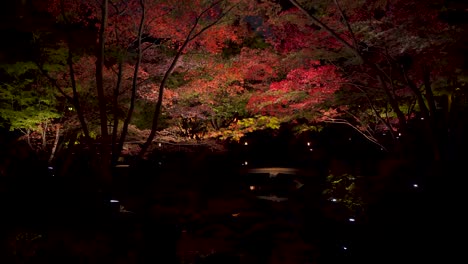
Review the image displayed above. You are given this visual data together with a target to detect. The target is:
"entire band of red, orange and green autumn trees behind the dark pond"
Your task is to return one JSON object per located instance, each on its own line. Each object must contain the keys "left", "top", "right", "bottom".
{"left": 0, "top": 0, "right": 467, "bottom": 175}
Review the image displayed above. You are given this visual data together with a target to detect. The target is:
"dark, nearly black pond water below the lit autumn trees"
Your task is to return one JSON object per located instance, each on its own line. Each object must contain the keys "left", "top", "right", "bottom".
{"left": 0, "top": 150, "right": 455, "bottom": 264}
